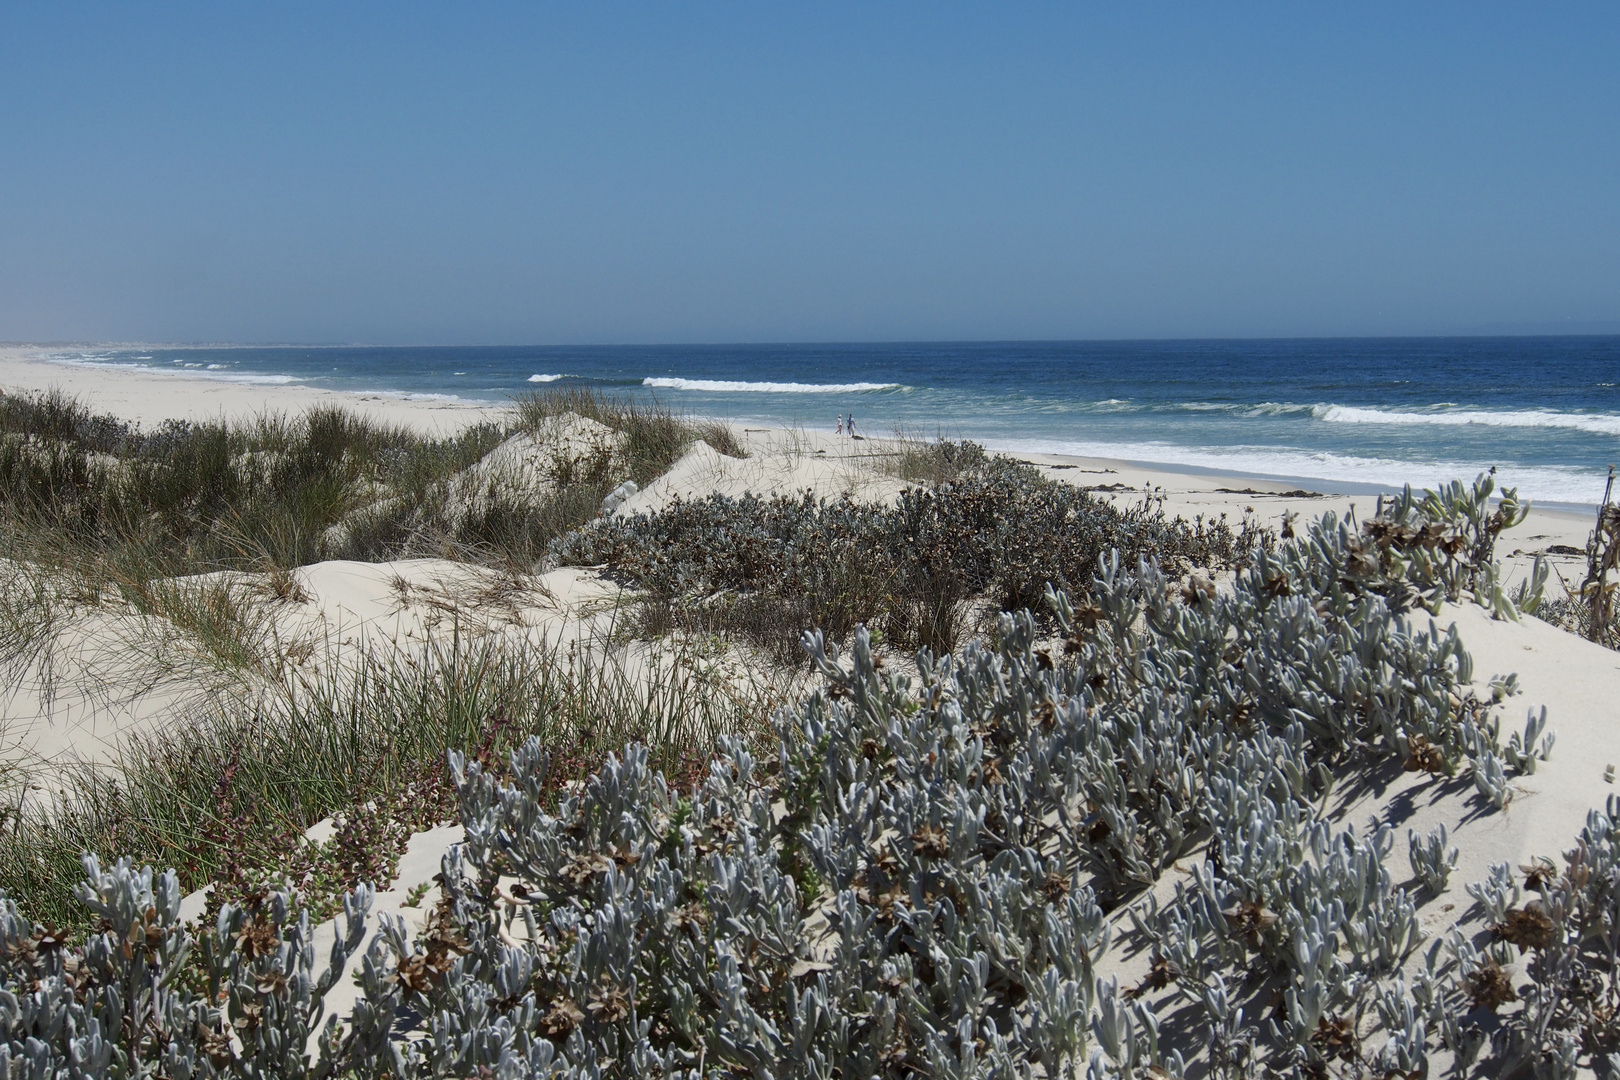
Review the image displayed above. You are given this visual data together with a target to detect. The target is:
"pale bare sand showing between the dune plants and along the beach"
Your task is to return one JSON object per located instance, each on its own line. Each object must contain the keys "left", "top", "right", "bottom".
{"left": 0, "top": 341, "right": 1620, "bottom": 1068}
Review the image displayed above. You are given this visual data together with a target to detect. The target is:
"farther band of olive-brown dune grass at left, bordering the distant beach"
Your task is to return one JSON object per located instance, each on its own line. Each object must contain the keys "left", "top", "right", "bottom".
{"left": 0, "top": 389, "right": 740, "bottom": 583}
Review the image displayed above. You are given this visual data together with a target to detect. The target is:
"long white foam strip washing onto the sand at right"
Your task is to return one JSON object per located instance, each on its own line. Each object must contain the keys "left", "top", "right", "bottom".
{"left": 985, "top": 439, "right": 1604, "bottom": 505}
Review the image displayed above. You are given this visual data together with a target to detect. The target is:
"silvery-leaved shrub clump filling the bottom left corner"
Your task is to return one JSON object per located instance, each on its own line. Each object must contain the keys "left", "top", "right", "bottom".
{"left": 0, "top": 855, "right": 392, "bottom": 1080}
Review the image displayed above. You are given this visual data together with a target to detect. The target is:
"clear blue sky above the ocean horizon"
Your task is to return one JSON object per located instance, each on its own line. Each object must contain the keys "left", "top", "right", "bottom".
{"left": 0, "top": 0, "right": 1620, "bottom": 345}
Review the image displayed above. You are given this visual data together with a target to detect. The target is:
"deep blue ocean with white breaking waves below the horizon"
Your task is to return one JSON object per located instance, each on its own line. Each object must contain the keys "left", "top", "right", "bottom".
{"left": 38, "top": 337, "right": 1620, "bottom": 507}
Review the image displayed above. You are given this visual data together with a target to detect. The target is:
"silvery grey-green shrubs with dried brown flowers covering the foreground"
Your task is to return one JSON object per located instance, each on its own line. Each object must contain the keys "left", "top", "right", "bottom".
{"left": 0, "top": 476, "right": 1620, "bottom": 1080}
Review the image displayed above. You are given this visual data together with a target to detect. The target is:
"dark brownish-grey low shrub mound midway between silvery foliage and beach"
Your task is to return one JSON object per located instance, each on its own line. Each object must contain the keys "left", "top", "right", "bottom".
{"left": 551, "top": 444, "right": 1270, "bottom": 664}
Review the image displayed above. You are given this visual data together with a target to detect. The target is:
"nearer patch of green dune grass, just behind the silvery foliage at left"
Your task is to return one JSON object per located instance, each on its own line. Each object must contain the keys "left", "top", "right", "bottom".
{"left": 0, "top": 636, "right": 784, "bottom": 923}
